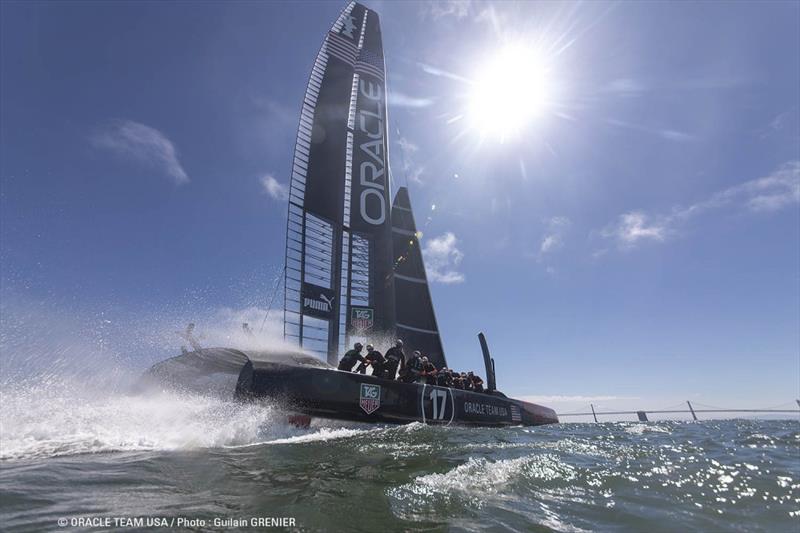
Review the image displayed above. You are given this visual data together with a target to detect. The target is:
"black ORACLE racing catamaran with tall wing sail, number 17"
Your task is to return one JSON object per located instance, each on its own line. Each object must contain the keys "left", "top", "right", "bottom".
{"left": 147, "top": 2, "right": 558, "bottom": 426}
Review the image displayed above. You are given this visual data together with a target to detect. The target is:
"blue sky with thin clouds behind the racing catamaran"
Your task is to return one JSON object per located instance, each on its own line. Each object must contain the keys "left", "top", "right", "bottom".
{"left": 0, "top": 1, "right": 800, "bottom": 418}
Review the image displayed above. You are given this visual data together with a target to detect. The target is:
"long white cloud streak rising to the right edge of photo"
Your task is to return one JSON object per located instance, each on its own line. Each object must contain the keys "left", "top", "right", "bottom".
{"left": 600, "top": 161, "right": 800, "bottom": 248}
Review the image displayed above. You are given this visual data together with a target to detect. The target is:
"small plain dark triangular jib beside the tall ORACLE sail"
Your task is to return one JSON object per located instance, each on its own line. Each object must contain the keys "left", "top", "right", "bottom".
{"left": 392, "top": 187, "right": 447, "bottom": 368}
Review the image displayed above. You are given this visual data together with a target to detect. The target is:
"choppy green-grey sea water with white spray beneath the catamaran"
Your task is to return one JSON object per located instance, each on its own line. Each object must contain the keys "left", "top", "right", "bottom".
{"left": 0, "top": 383, "right": 800, "bottom": 532}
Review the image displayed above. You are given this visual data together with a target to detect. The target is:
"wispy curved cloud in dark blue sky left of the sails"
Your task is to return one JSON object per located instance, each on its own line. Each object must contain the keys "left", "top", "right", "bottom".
{"left": 90, "top": 120, "right": 189, "bottom": 185}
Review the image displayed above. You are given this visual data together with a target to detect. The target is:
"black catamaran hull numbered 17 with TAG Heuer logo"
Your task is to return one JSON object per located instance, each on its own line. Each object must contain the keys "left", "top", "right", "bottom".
{"left": 142, "top": 349, "right": 558, "bottom": 427}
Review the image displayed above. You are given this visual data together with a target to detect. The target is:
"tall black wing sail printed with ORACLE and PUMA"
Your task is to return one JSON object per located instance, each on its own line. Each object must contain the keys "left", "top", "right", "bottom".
{"left": 284, "top": 2, "right": 395, "bottom": 363}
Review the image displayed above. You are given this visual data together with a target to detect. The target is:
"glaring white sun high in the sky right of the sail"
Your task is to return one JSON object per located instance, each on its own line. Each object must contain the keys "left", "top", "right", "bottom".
{"left": 468, "top": 45, "right": 551, "bottom": 142}
